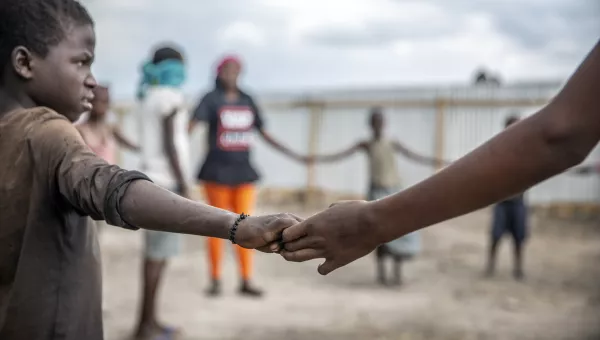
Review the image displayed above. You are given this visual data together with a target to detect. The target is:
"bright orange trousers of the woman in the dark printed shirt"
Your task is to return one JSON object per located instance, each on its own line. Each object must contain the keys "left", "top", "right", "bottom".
{"left": 203, "top": 183, "right": 256, "bottom": 280}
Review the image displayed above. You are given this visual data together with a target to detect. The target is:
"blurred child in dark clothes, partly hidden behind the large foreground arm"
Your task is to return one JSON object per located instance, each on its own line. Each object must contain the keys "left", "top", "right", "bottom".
{"left": 485, "top": 116, "right": 528, "bottom": 280}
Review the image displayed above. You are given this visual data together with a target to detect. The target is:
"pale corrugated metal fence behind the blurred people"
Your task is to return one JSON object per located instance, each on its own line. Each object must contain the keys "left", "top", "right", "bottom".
{"left": 113, "top": 82, "right": 600, "bottom": 204}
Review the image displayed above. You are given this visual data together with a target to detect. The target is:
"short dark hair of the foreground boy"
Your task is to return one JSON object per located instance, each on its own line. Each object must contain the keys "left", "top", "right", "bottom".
{"left": 0, "top": 0, "right": 94, "bottom": 75}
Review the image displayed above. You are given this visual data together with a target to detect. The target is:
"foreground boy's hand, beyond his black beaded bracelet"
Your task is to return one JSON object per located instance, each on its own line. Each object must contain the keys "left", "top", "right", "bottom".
{"left": 235, "top": 213, "right": 303, "bottom": 253}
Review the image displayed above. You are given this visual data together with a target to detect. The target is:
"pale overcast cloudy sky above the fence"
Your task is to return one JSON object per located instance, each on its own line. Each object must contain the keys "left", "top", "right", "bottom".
{"left": 83, "top": 0, "right": 600, "bottom": 98}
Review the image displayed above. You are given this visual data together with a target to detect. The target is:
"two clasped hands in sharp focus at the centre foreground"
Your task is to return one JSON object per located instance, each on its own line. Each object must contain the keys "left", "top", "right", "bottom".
{"left": 236, "top": 201, "right": 386, "bottom": 275}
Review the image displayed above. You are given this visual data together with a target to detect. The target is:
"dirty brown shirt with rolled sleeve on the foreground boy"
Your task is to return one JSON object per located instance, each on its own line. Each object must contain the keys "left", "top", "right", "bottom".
{"left": 0, "top": 108, "right": 146, "bottom": 340}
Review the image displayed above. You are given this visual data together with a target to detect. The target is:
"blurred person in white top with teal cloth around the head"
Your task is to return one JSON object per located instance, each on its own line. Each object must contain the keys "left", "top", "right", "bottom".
{"left": 135, "top": 47, "right": 190, "bottom": 339}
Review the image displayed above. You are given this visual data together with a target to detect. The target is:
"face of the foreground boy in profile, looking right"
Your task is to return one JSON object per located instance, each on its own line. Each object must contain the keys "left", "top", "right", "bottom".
{"left": 28, "top": 25, "right": 97, "bottom": 121}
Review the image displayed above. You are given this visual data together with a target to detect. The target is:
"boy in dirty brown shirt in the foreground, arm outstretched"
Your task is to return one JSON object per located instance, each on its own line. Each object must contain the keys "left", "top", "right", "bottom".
{"left": 0, "top": 0, "right": 299, "bottom": 340}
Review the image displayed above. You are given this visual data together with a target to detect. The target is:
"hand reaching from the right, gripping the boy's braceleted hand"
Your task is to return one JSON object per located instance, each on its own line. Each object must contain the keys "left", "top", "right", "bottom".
{"left": 281, "top": 201, "right": 385, "bottom": 275}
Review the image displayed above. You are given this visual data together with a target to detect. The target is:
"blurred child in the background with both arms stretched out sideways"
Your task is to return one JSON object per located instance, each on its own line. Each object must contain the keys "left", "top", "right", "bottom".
{"left": 309, "top": 108, "right": 443, "bottom": 285}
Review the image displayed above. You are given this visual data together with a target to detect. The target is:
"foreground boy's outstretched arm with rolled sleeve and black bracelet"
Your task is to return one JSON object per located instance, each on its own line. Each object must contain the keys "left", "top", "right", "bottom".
{"left": 29, "top": 112, "right": 300, "bottom": 251}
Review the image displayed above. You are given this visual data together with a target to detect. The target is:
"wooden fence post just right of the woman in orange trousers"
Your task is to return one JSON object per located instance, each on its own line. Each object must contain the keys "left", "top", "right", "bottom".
{"left": 304, "top": 102, "right": 324, "bottom": 208}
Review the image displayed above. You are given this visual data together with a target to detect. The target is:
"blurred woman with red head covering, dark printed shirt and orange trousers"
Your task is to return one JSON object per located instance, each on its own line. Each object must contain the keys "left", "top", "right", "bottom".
{"left": 189, "top": 56, "right": 301, "bottom": 297}
